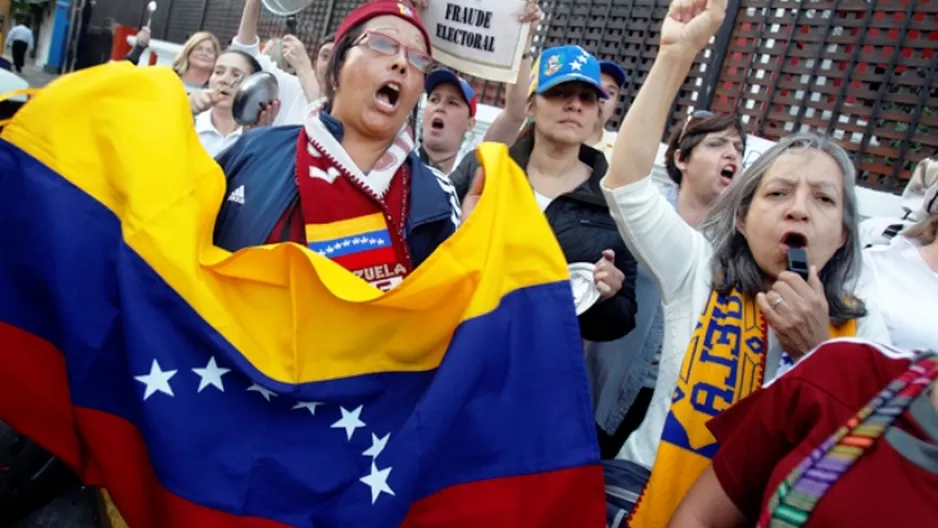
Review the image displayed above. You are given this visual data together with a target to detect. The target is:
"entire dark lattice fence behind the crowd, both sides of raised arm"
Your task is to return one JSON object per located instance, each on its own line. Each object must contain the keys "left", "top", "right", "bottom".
{"left": 84, "top": 0, "right": 938, "bottom": 192}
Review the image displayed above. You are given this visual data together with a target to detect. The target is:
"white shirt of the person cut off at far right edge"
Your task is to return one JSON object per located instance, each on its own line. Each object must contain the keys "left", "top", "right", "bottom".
{"left": 856, "top": 235, "right": 938, "bottom": 350}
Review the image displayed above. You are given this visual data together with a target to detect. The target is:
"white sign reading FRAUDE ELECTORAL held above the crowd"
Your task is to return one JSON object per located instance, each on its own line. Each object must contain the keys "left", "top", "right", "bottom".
{"left": 421, "top": 0, "right": 530, "bottom": 83}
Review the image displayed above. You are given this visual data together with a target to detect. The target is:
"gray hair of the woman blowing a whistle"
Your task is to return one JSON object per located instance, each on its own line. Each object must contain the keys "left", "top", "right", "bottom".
{"left": 700, "top": 132, "right": 866, "bottom": 326}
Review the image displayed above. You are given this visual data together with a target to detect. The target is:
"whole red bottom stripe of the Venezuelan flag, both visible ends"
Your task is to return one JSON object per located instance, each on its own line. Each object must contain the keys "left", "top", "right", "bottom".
{"left": 0, "top": 322, "right": 605, "bottom": 528}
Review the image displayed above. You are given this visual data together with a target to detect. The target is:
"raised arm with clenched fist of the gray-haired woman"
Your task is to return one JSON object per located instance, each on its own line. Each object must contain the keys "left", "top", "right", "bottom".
{"left": 602, "top": 0, "right": 726, "bottom": 303}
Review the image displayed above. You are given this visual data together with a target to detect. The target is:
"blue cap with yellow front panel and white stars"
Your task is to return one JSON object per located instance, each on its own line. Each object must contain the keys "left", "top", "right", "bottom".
{"left": 528, "top": 44, "right": 609, "bottom": 99}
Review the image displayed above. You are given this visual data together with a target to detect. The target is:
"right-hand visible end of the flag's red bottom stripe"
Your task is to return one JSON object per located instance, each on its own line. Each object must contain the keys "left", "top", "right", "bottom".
{"left": 401, "top": 464, "right": 606, "bottom": 528}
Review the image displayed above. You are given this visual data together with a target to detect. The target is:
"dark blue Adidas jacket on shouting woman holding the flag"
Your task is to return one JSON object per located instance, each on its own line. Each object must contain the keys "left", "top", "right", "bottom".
{"left": 215, "top": 113, "right": 459, "bottom": 267}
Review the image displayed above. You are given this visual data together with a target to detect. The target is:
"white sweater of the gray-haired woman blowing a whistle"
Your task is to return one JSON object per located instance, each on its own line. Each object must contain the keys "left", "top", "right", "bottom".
{"left": 603, "top": 177, "right": 889, "bottom": 468}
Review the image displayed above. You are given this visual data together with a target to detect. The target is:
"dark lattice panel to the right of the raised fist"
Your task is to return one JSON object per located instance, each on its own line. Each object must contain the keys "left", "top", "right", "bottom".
{"left": 712, "top": 0, "right": 938, "bottom": 192}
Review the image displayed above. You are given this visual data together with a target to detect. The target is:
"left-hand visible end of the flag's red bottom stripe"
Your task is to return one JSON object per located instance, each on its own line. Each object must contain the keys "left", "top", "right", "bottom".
{"left": 0, "top": 322, "right": 287, "bottom": 528}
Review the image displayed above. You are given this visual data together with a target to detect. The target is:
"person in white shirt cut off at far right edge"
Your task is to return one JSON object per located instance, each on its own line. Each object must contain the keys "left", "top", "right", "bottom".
{"left": 856, "top": 167, "right": 938, "bottom": 350}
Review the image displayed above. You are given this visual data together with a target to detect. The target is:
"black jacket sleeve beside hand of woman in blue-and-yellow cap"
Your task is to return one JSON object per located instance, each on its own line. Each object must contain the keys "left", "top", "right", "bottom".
{"left": 580, "top": 244, "right": 638, "bottom": 341}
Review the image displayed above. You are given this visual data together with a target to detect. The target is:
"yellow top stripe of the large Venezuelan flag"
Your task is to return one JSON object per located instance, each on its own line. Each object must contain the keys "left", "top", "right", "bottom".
{"left": 3, "top": 65, "right": 573, "bottom": 383}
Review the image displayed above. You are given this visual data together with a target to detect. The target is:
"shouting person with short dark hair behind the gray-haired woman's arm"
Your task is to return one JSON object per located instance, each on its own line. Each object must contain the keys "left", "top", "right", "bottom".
{"left": 586, "top": 109, "right": 746, "bottom": 460}
